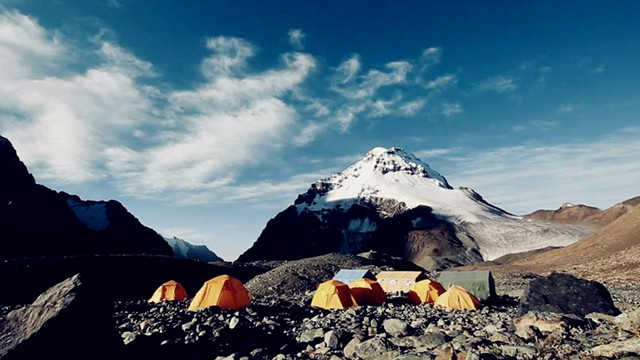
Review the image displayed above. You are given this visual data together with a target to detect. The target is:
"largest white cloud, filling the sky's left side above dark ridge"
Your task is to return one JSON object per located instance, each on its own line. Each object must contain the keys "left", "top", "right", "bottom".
{"left": 0, "top": 12, "right": 322, "bottom": 202}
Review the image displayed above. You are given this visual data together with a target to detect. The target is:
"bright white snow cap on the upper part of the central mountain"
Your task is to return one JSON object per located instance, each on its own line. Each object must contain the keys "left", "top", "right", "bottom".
{"left": 296, "top": 147, "right": 502, "bottom": 222}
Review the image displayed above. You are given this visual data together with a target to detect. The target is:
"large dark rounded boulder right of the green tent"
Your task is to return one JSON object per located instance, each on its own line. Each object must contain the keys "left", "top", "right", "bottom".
{"left": 519, "top": 273, "right": 620, "bottom": 316}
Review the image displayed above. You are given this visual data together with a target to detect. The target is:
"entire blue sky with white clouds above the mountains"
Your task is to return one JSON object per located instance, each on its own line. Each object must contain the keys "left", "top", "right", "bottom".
{"left": 0, "top": 0, "right": 640, "bottom": 260}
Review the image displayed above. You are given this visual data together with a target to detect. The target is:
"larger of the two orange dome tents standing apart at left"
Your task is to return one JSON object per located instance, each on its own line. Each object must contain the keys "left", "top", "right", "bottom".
{"left": 189, "top": 275, "right": 251, "bottom": 310}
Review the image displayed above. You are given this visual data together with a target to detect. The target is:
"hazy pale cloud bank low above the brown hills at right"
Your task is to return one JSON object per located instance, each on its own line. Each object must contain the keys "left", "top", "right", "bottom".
{"left": 448, "top": 128, "right": 640, "bottom": 213}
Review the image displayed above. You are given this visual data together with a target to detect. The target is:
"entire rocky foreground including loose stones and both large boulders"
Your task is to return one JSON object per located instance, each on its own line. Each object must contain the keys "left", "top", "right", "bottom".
{"left": 0, "top": 258, "right": 640, "bottom": 360}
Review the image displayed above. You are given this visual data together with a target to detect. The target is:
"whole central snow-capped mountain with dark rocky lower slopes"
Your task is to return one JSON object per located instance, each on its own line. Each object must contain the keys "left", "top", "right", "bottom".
{"left": 239, "top": 147, "right": 588, "bottom": 269}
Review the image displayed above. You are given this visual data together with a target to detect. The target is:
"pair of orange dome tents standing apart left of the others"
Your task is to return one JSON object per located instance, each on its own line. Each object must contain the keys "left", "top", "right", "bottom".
{"left": 149, "top": 275, "right": 251, "bottom": 311}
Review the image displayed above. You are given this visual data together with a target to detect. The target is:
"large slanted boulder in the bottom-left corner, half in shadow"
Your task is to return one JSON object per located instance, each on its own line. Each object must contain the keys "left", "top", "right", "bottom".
{"left": 0, "top": 274, "right": 122, "bottom": 360}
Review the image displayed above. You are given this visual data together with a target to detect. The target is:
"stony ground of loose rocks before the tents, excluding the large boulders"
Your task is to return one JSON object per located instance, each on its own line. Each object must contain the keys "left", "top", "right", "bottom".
{"left": 114, "top": 274, "right": 640, "bottom": 360}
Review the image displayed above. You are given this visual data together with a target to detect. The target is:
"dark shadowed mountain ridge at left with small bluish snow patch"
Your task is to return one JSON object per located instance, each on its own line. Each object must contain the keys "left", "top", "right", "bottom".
{"left": 0, "top": 136, "right": 173, "bottom": 259}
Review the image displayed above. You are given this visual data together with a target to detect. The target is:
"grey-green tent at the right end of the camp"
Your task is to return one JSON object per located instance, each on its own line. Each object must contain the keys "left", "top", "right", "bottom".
{"left": 438, "top": 270, "right": 496, "bottom": 301}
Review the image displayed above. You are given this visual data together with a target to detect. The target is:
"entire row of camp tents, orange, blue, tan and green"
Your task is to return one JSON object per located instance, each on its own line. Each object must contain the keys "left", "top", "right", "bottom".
{"left": 149, "top": 270, "right": 495, "bottom": 310}
